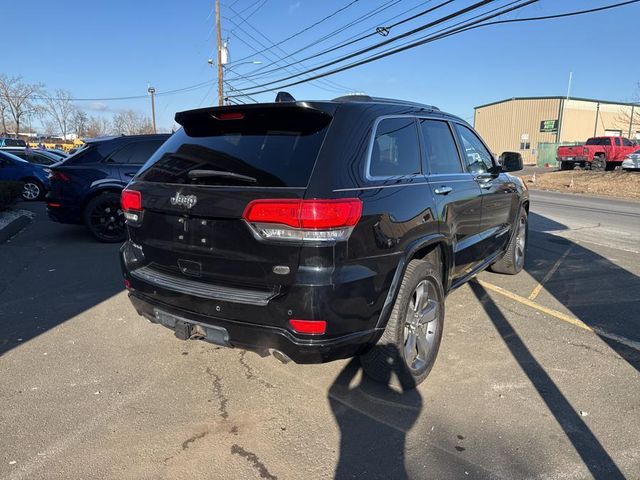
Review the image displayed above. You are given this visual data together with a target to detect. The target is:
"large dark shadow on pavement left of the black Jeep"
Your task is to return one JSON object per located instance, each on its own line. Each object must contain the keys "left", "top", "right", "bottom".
{"left": 0, "top": 204, "right": 123, "bottom": 356}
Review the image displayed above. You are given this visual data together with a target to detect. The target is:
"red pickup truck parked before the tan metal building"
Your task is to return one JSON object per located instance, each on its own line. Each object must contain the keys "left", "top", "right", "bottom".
{"left": 557, "top": 137, "right": 638, "bottom": 170}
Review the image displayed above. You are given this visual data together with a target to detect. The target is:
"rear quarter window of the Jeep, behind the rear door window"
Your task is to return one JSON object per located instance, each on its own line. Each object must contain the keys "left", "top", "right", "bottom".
{"left": 369, "top": 118, "right": 420, "bottom": 177}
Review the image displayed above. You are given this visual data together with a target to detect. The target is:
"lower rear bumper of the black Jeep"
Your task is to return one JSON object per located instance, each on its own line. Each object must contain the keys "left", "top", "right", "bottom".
{"left": 129, "top": 292, "right": 380, "bottom": 363}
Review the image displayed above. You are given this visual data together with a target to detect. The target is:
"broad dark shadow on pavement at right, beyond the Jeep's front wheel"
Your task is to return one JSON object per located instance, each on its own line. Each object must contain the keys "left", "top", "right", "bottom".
{"left": 525, "top": 213, "right": 640, "bottom": 371}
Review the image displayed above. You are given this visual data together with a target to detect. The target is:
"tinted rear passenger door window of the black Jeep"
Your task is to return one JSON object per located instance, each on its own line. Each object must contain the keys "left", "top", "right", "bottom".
{"left": 420, "top": 120, "right": 462, "bottom": 174}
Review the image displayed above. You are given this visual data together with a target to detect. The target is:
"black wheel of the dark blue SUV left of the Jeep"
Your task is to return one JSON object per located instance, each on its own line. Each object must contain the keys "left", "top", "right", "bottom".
{"left": 84, "top": 192, "right": 126, "bottom": 243}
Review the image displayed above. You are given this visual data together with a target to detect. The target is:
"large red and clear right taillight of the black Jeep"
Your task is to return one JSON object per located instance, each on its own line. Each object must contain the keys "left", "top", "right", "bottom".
{"left": 243, "top": 198, "right": 362, "bottom": 242}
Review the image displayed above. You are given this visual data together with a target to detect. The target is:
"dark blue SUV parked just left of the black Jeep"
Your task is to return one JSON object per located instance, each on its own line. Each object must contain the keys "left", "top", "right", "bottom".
{"left": 47, "top": 134, "right": 169, "bottom": 242}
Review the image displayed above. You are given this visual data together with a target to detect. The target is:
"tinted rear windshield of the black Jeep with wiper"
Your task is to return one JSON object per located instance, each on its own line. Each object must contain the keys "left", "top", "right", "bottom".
{"left": 138, "top": 110, "right": 330, "bottom": 187}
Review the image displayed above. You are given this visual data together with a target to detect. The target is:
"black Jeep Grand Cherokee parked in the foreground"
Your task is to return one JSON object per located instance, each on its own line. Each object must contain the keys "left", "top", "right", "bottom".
{"left": 121, "top": 96, "right": 529, "bottom": 385}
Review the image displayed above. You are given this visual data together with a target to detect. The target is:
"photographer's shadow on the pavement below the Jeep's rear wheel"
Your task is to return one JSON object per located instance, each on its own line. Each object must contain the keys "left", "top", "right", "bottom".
{"left": 328, "top": 358, "right": 422, "bottom": 480}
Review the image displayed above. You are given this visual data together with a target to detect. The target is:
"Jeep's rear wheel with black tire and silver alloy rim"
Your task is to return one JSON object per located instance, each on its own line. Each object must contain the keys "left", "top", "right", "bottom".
{"left": 360, "top": 260, "right": 444, "bottom": 390}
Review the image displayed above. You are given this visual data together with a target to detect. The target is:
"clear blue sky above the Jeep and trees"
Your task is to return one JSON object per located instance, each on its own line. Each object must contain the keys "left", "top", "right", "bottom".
{"left": 0, "top": 0, "right": 640, "bottom": 128}
